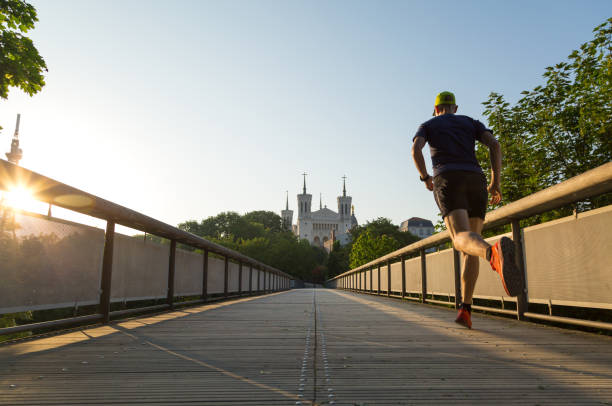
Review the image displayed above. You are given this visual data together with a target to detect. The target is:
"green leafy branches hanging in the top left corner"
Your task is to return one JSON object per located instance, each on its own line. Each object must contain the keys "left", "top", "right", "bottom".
{"left": 0, "top": 0, "right": 47, "bottom": 104}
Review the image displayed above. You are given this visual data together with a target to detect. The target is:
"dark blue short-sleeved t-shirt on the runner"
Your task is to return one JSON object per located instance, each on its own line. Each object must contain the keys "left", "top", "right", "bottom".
{"left": 412, "top": 114, "right": 492, "bottom": 176}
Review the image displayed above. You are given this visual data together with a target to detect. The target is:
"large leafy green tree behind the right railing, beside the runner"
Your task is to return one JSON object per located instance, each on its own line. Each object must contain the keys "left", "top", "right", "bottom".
{"left": 477, "top": 18, "right": 612, "bottom": 223}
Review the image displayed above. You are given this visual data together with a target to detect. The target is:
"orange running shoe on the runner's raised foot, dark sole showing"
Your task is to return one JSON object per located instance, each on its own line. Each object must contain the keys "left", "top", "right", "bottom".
{"left": 490, "top": 237, "right": 525, "bottom": 296}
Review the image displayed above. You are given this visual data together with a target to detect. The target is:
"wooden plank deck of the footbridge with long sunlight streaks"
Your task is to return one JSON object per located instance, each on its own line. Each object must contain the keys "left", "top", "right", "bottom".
{"left": 0, "top": 289, "right": 612, "bottom": 405}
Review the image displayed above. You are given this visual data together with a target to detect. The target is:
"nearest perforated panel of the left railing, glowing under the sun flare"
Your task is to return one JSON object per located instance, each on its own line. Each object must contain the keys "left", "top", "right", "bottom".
{"left": 0, "top": 207, "right": 104, "bottom": 314}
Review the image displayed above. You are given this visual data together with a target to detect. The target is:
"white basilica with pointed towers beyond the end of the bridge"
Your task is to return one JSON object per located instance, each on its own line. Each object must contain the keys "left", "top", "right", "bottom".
{"left": 281, "top": 174, "right": 358, "bottom": 248}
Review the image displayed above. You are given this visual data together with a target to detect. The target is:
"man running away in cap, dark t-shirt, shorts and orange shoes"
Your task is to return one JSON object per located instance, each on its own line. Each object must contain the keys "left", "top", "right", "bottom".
{"left": 412, "top": 92, "right": 524, "bottom": 328}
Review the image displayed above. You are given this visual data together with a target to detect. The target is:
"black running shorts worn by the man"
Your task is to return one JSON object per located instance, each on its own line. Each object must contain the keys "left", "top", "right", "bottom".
{"left": 433, "top": 171, "right": 488, "bottom": 220}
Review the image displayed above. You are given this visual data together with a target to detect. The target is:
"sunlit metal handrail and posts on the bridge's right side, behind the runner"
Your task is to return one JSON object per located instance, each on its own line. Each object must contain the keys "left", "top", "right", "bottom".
{"left": 327, "top": 162, "right": 612, "bottom": 329}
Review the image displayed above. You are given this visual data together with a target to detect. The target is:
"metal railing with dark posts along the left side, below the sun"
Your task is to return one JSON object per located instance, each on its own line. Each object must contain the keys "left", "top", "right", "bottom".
{"left": 0, "top": 160, "right": 292, "bottom": 335}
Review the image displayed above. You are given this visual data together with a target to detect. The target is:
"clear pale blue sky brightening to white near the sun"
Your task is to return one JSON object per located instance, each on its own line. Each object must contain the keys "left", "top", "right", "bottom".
{"left": 0, "top": 0, "right": 612, "bottom": 230}
